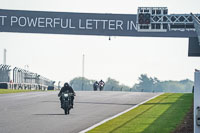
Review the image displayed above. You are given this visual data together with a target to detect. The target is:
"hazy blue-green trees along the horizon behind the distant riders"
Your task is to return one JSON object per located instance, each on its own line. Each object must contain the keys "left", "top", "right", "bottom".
{"left": 70, "top": 74, "right": 194, "bottom": 93}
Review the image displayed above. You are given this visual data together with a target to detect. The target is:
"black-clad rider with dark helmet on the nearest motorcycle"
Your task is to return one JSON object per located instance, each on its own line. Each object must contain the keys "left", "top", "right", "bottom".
{"left": 58, "top": 82, "right": 75, "bottom": 108}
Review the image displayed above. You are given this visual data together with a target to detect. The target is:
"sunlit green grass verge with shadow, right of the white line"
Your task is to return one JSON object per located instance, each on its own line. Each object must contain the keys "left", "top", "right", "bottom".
{"left": 88, "top": 93, "right": 193, "bottom": 133}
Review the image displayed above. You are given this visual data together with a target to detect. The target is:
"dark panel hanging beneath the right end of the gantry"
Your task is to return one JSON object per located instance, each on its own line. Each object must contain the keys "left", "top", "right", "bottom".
{"left": 188, "top": 37, "right": 200, "bottom": 57}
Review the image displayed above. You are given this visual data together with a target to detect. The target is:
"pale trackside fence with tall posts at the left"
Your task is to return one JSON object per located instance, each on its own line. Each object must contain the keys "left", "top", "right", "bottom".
{"left": 0, "top": 64, "right": 55, "bottom": 90}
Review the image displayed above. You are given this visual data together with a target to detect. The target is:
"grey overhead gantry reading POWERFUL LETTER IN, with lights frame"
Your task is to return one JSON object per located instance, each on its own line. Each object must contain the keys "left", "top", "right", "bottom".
{"left": 0, "top": 7, "right": 200, "bottom": 56}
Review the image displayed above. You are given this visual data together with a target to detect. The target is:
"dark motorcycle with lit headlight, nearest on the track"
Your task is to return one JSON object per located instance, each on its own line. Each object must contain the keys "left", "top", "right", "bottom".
{"left": 61, "top": 92, "right": 74, "bottom": 115}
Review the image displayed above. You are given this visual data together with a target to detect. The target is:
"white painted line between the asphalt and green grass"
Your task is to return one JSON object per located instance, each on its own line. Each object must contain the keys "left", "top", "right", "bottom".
{"left": 79, "top": 93, "right": 164, "bottom": 133}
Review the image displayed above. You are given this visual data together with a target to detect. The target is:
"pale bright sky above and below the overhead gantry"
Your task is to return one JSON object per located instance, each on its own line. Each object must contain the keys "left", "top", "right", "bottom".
{"left": 0, "top": 0, "right": 200, "bottom": 86}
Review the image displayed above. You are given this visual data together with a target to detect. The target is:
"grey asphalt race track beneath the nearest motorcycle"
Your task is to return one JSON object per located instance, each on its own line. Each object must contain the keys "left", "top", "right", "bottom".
{"left": 0, "top": 91, "right": 158, "bottom": 133}
